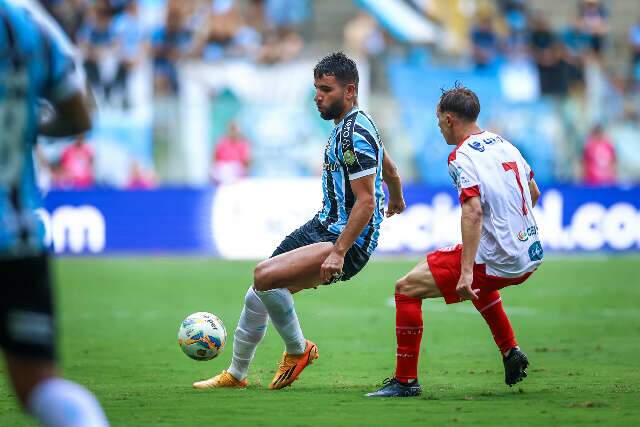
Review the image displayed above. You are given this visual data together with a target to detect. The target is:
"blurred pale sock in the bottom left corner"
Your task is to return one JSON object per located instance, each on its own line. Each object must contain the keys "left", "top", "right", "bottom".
{"left": 28, "top": 378, "right": 109, "bottom": 427}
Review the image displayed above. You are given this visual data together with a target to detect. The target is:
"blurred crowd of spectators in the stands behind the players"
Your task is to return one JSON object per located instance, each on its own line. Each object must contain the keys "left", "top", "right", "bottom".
{"left": 40, "top": 0, "right": 640, "bottom": 188}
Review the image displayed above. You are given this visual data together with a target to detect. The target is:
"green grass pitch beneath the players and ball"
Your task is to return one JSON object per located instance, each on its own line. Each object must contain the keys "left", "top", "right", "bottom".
{"left": 0, "top": 257, "right": 640, "bottom": 427}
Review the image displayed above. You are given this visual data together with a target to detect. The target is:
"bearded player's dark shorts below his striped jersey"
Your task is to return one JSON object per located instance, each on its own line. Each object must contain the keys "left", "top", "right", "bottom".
{"left": 271, "top": 216, "right": 369, "bottom": 281}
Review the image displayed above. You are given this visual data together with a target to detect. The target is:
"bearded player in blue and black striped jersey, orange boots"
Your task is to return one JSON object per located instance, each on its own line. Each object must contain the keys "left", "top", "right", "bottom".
{"left": 194, "top": 52, "right": 405, "bottom": 389}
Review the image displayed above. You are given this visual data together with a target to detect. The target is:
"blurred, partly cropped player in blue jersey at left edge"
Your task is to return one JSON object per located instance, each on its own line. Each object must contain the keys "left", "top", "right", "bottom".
{"left": 0, "top": 0, "right": 108, "bottom": 427}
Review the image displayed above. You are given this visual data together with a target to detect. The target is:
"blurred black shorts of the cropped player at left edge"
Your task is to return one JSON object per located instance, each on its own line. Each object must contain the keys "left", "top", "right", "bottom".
{"left": 0, "top": 255, "right": 56, "bottom": 361}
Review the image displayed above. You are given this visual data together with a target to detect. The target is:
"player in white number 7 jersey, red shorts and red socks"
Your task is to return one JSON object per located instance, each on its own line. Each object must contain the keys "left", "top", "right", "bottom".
{"left": 367, "top": 85, "right": 543, "bottom": 397}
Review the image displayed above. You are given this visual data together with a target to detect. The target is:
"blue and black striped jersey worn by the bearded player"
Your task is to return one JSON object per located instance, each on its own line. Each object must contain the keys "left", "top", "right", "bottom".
{"left": 318, "top": 107, "right": 384, "bottom": 254}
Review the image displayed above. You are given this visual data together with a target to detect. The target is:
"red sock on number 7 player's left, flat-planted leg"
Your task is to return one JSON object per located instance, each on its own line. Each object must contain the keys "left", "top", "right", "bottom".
{"left": 395, "top": 294, "right": 422, "bottom": 382}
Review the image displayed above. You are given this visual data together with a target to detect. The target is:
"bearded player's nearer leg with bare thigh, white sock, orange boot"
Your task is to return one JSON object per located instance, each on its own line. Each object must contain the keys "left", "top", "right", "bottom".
{"left": 253, "top": 242, "right": 333, "bottom": 389}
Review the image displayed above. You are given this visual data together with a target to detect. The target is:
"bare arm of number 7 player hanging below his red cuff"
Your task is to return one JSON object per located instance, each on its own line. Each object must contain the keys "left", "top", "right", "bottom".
{"left": 456, "top": 197, "right": 482, "bottom": 300}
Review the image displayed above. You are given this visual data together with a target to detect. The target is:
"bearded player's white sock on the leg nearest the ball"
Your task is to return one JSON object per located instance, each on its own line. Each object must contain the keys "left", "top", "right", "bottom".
{"left": 228, "top": 286, "right": 269, "bottom": 381}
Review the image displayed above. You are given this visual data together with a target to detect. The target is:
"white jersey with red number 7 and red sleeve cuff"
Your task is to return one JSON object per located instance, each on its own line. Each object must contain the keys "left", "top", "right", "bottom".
{"left": 449, "top": 131, "right": 543, "bottom": 277}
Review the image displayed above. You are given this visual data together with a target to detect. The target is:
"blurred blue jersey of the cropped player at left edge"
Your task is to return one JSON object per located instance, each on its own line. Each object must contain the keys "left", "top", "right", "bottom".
{"left": 0, "top": 0, "right": 82, "bottom": 257}
